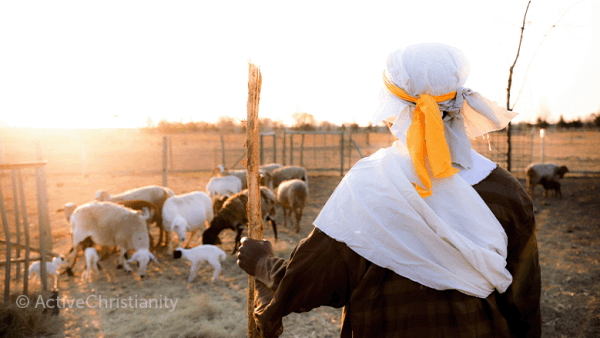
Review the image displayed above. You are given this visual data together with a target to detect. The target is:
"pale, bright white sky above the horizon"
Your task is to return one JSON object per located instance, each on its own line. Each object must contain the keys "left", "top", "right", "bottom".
{"left": 0, "top": 0, "right": 600, "bottom": 128}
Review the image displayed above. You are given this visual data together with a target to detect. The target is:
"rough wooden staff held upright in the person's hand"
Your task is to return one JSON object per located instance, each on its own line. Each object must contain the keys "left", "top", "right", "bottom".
{"left": 246, "top": 63, "right": 263, "bottom": 337}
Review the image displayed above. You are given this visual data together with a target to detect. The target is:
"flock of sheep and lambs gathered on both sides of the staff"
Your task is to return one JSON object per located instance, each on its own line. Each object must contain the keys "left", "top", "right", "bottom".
{"left": 30, "top": 163, "right": 308, "bottom": 284}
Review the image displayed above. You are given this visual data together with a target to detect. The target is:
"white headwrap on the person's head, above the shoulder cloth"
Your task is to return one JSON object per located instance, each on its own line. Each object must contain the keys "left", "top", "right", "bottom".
{"left": 372, "top": 43, "right": 517, "bottom": 169}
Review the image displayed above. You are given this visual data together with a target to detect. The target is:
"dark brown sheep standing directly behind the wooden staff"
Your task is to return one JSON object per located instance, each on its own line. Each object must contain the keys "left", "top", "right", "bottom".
{"left": 202, "top": 186, "right": 277, "bottom": 254}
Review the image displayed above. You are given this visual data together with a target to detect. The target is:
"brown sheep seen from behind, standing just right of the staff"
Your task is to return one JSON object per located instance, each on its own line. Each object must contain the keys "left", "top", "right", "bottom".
{"left": 277, "top": 178, "right": 308, "bottom": 232}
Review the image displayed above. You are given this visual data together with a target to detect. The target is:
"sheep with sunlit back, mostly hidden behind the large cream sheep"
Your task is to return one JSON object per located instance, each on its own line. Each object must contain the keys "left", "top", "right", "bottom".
{"left": 96, "top": 185, "right": 175, "bottom": 246}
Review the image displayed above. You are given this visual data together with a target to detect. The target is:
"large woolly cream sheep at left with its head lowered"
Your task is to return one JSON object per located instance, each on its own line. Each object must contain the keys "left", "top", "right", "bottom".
{"left": 67, "top": 201, "right": 156, "bottom": 278}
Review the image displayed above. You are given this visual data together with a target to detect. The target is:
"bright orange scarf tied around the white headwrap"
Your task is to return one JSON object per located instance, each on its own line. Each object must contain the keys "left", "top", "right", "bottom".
{"left": 383, "top": 72, "right": 458, "bottom": 198}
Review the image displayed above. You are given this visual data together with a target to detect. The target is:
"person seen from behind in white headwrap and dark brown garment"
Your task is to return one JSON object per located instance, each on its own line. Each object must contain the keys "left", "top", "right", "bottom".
{"left": 238, "top": 43, "right": 541, "bottom": 337}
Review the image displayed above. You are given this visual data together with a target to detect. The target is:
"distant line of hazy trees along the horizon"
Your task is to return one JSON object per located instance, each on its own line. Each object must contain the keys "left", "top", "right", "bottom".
{"left": 142, "top": 111, "right": 600, "bottom": 134}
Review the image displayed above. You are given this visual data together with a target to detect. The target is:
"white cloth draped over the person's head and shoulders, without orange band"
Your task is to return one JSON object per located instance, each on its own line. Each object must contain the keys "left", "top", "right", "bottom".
{"left": 314, "top": 44, "right": 515, "bottom": 298}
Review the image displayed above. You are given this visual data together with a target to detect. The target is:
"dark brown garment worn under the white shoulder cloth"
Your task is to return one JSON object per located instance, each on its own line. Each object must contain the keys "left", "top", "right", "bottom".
{"left": 254, "top": 167, "right": 541, "bottom": 337}
